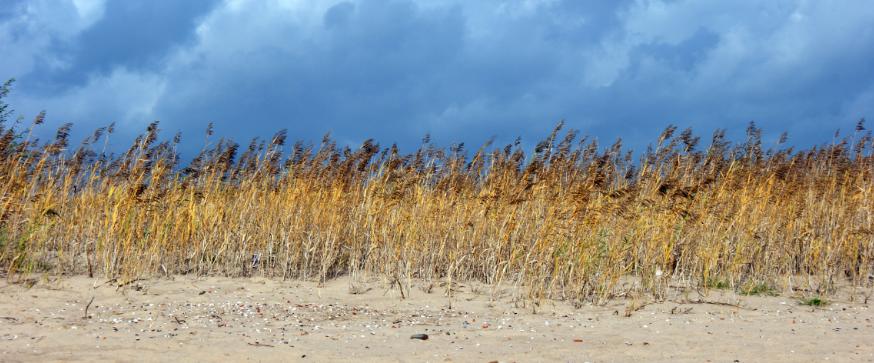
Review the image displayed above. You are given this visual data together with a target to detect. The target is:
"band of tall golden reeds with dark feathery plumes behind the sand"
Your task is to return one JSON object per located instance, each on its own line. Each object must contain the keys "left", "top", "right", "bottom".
{"left": 0, "top": 98, "right": 874, "bottom": 303}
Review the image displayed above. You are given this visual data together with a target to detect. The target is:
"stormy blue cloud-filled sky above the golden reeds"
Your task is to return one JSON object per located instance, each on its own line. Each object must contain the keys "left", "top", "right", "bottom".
{"left": 0, "top": 0, "right": 874, "bottom": 155}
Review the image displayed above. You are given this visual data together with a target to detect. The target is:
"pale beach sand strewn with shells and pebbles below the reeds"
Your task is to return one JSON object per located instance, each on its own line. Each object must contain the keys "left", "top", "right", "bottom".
{"left": 0, "top": 277, "right": 874, "bottom": 362}
